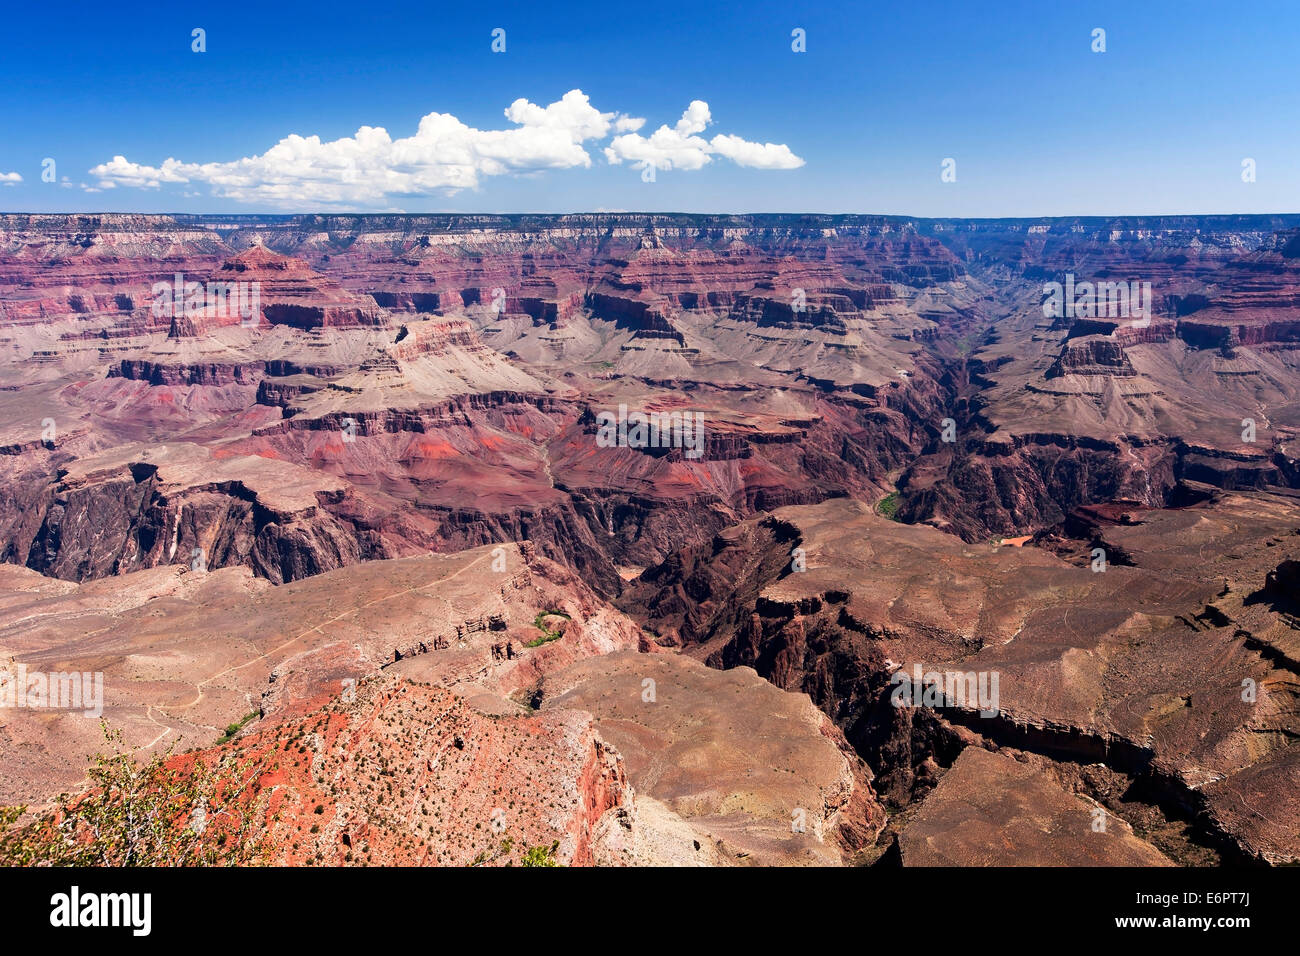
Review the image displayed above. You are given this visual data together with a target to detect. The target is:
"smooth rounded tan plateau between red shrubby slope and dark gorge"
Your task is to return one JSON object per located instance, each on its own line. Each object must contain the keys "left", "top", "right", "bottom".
{"left": 542, "top": 652, "right": 885, "bottom": 865}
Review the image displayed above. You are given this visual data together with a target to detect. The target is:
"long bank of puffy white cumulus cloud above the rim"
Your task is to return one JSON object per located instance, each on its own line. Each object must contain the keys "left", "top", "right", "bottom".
{"left": 90, "top": 90, "right": 803, "bottom": 208}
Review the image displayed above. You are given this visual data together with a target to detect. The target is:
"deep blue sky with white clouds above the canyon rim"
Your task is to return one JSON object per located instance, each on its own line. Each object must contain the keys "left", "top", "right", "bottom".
{"left": 0, "top": 0, "right": 1300, "bottom": 216}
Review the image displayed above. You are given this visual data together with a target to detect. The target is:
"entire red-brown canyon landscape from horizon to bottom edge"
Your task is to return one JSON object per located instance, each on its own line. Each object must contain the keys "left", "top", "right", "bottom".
{"left": 0, "top": 213, "right": 1300, "bottom": 866}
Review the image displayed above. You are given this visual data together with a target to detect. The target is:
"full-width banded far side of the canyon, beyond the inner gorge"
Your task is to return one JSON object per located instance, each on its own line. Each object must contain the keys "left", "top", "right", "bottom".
{"left": 0, "top": 215, "right": 1300, "bottom": 572}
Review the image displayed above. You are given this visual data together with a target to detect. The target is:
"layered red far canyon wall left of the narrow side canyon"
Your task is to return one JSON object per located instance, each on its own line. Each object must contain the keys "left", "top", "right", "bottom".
{"left": 5, "top": 217, "right": 972, "bottom": 593}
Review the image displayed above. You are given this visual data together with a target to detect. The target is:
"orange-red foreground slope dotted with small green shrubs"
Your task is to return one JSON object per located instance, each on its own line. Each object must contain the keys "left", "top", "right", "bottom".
{"left": 173, "top": 680, "right": 634, "bottom": 866}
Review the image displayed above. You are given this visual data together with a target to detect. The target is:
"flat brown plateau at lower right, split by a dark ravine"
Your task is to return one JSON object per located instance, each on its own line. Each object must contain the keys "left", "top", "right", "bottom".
{"left": 621, "top": 496, "right": 1300, "bottom": 864}
